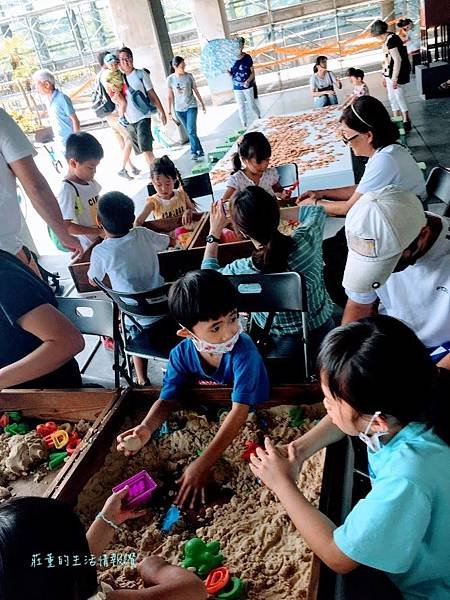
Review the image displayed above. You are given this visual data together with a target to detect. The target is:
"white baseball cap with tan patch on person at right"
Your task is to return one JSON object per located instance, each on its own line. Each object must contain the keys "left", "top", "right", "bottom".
{"left": 342, "top": 185, "right": 427, "bottom": 294}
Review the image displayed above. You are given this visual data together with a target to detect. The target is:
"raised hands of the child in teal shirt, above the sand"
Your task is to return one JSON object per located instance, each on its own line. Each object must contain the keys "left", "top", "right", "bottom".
{"left": 250, "top": 437, "right": 298, "bottom": 494}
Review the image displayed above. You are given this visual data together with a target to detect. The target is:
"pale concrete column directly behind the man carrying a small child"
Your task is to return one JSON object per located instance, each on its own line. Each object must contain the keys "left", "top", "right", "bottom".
{"left": 110, "top": 0, "right": 173, "bottom": 109}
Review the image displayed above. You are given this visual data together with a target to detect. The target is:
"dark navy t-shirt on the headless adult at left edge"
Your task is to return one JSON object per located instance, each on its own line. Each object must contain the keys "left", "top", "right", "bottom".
{"left": 0, "top": 250, "right": 81, "bottom": 388}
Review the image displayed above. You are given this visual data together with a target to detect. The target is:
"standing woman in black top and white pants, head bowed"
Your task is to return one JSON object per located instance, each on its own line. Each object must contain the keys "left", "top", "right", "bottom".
{"left": 370, "top": 21, "right": 411, "bottom": 131}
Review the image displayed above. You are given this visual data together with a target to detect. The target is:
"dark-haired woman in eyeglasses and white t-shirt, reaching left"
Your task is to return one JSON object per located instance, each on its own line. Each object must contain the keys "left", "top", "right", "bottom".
{"left": 297, "top": 96, "right": 426, "bottom": 307}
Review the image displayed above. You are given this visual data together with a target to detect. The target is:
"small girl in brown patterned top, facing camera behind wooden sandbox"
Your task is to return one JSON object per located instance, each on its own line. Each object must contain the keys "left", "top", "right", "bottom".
{"left": 134, "top": 155, "right": 197, "bottom": 227}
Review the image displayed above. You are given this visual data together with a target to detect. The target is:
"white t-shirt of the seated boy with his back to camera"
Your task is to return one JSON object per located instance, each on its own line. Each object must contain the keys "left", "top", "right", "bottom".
{"left": 88, "top": 227, "right": 170, "bottom": 325}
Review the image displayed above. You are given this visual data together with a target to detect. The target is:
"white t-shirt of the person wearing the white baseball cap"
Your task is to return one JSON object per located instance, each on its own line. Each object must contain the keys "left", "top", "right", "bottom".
{"left": 345, "top": 215, "right": 450, "bottom": 348}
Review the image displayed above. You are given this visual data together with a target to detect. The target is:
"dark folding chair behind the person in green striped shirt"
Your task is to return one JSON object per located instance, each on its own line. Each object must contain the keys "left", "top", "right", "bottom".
{"left": 228, "top": 272, "right": 311, "bottom": 380}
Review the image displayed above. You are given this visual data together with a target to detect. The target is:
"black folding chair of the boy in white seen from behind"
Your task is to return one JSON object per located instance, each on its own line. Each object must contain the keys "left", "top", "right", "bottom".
{"left": 94, "top": 279, "right": 180, "bottom": 385}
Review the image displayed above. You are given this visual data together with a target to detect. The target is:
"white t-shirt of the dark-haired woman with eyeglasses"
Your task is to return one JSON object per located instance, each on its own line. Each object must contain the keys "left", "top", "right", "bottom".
{"left": 356, "top": 144, "right": 427, "bottom": 199}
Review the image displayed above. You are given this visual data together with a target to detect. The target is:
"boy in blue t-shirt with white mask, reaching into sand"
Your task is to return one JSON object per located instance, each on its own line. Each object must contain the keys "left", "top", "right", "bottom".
{"left": 117, "top": 269, "right": 269, "bottom": 508}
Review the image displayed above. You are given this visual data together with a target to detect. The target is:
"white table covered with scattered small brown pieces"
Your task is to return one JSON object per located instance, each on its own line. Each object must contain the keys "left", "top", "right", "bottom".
{"left": 210, "top": 107, "right": 355, "bottom": 199}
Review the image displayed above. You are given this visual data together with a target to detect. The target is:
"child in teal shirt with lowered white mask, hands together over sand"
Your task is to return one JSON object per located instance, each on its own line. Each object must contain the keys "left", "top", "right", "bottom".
{"left": 250, "top": 315, "right": 450, "bottom": 600}
